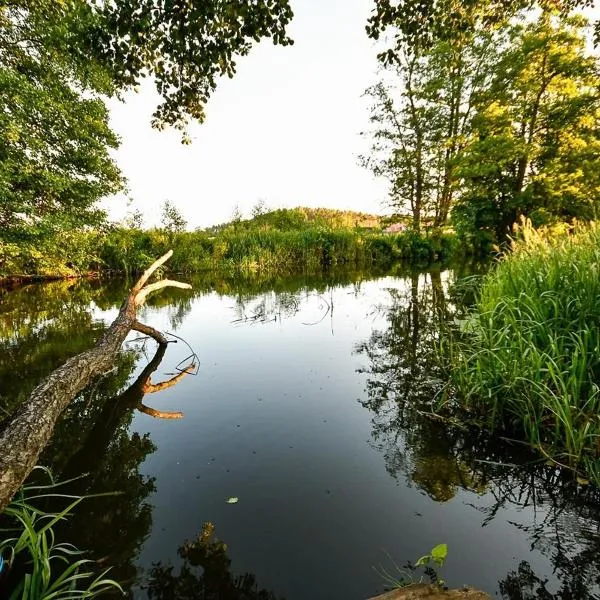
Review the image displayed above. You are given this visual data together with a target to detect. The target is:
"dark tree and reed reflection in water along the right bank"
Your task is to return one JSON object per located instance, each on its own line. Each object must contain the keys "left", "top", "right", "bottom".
{"left": 358, "top": 273, "right": 600, "bottom": 600}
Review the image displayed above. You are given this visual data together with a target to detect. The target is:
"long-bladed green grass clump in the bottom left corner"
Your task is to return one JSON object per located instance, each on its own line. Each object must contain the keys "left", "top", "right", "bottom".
{"left": 0, "top": 467, "right": 123, "bottom": 600}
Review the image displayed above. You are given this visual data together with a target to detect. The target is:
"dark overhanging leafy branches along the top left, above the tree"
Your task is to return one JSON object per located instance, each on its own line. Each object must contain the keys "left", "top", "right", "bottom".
{"left": 0, "top": 0, "right": 293, "bottom": 128}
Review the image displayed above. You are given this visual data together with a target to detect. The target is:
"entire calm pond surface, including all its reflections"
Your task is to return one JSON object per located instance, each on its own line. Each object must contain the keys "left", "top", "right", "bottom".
{"left": 0, "top": 270, "right": 600, "bottom": 600}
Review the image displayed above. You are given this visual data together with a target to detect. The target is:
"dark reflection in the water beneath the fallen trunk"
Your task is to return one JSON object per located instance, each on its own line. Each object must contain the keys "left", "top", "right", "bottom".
{"left": 35, "top": 344, "right": 195, "bottom": 582}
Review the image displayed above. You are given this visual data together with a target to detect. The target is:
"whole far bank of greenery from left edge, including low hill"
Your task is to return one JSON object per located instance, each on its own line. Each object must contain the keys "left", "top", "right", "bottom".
{"left": 0, "top": 211, "right": 454, "bottom": 278}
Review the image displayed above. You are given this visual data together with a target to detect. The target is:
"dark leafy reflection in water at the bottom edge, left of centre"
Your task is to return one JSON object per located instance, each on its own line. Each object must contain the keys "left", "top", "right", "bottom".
{"left": 148, "top": 523, "right": 283, "bottom": 600}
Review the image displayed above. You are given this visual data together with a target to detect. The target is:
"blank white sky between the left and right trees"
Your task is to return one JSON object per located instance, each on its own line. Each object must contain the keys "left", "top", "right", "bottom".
{"left": 106, "top": 0, "right": 386, "bottom": 229}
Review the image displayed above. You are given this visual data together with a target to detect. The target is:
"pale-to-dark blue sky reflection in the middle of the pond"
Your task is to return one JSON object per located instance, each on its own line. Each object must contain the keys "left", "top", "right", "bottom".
{"left": 101, "top": 278, "right": 600, "bottom": 600}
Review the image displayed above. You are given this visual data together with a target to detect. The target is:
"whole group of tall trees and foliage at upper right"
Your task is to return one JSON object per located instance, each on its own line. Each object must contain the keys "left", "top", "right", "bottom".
{"left": 363, "top": 0, "right": 600, "bottom": 244}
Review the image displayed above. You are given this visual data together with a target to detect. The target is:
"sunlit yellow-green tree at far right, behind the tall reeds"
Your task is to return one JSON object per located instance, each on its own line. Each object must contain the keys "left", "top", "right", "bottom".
{"left": 453, "top": 14, "right": 600, "bottom": 242}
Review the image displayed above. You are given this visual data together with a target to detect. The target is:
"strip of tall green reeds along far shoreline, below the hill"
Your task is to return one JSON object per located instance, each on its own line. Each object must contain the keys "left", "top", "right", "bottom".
{"left": 100, "top": 226, "right": 454, "bottom": 273}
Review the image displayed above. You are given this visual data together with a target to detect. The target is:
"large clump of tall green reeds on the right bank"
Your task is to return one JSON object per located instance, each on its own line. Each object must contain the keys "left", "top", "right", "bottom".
{"left": 446, "top": 224, "right": 600, "bottom": 484}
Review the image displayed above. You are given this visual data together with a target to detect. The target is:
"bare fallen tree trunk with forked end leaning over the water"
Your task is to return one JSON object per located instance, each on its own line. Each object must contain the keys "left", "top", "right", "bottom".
{"left": 0, "top": 251, "right": 191, "bottom": 513}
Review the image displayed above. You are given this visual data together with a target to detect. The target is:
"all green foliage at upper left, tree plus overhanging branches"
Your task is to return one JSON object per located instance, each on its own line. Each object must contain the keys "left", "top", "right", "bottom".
{"left": 0, "top": 0, "right": 292, "bottom": 248}
